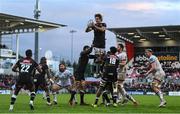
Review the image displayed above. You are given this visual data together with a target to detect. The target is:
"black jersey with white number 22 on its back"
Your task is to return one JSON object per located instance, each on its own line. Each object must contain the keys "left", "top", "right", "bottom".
{"left": 16, "top": 58, "right": 38, "bottom": 76}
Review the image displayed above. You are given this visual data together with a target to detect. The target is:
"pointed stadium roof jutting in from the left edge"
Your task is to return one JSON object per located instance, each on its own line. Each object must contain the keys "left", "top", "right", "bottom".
{"left": 0, "top": 13, "right": 66, "bottom": 35}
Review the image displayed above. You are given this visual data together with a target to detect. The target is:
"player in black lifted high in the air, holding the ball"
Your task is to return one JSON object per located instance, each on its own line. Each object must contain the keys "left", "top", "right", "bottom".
{"left": 85, "top": 14, "right": 106, "bottom": 74}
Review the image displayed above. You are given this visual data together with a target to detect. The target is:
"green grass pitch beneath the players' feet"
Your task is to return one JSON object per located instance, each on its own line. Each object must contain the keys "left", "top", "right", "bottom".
{"left": 0, "top": 94, "right": 180, "bottom": 113}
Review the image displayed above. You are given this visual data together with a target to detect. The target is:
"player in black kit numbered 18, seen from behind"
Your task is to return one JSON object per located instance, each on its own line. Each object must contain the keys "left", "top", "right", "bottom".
{"left": 92, "top": 47, "right": 119, "bottom": 107}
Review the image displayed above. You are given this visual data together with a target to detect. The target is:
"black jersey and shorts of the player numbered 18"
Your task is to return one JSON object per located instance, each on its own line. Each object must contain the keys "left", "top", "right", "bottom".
{"left": 102, "top": 55, "right": 119, "bottom": 82}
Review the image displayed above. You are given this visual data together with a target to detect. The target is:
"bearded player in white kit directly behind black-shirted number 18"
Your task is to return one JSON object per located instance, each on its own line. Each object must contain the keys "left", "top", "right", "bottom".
{"left": 116, "top": 44, "right": 138, "bottom": 105}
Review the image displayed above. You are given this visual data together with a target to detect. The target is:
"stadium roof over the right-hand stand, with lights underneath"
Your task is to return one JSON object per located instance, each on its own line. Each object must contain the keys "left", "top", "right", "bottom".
{"left": 108, "top": 25, "right": 180, "bottom": 43}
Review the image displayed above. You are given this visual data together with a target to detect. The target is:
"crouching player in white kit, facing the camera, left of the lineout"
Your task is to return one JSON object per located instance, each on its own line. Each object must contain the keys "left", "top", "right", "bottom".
{"left": 52, "top": 63, "right": 75, "bottom": 104}
